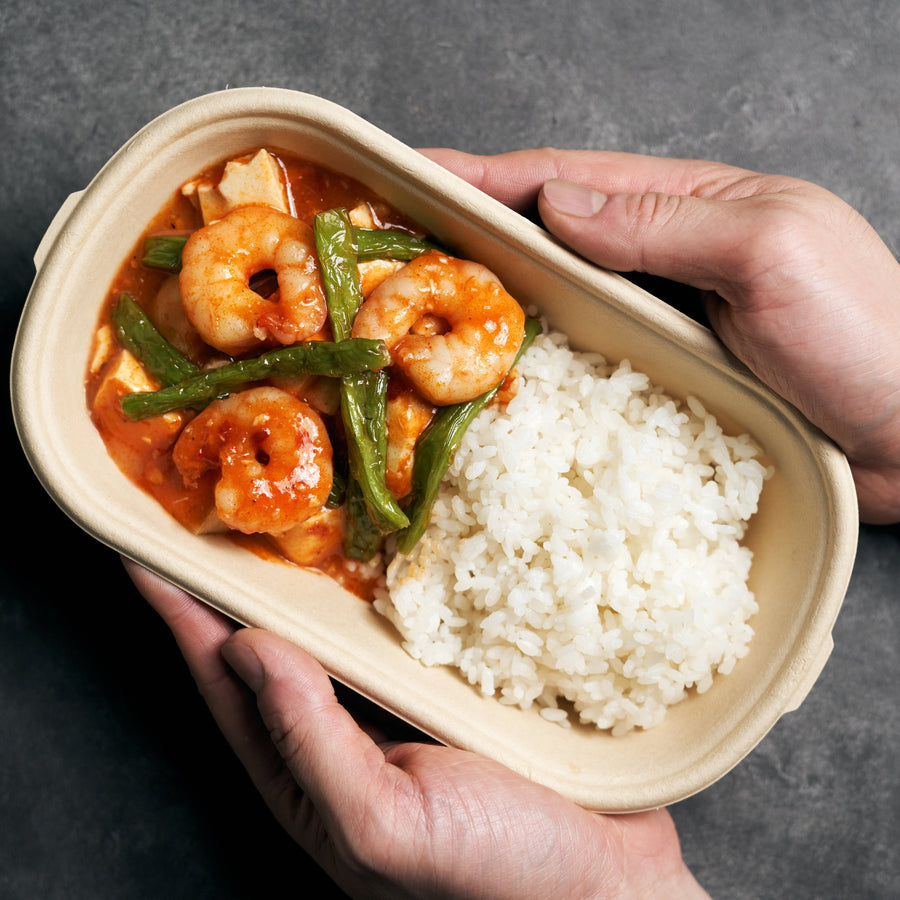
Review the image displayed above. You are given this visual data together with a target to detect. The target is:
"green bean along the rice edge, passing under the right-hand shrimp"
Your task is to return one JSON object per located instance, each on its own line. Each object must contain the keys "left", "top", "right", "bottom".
{"left": 397, "top": 318, "right": 541, "bottom": 553}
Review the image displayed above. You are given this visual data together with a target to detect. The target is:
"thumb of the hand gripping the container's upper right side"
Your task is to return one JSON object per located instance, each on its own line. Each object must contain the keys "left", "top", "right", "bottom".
{"left": 538, "top": 179, "right": 747, "bottom": 290}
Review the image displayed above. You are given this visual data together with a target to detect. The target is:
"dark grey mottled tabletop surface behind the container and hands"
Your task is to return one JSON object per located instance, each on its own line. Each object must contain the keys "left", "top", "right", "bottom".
{"left": 0, "top": 0, "right": 900, "bottom": 900}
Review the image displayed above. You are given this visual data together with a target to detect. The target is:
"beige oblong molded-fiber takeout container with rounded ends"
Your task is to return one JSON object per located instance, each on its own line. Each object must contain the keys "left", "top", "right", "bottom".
{"left": 12, "top": 88, "right": 858, "bottom": 812}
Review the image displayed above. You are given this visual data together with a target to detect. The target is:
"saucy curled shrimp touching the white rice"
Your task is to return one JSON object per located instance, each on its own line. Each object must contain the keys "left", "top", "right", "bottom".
{"left": 352, "top": 250, "right": 525, "bottom": 406}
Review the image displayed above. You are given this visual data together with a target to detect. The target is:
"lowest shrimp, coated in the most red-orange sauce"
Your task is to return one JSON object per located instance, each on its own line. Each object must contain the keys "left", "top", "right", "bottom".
{"left": 172, "top": 387, "right": 333, "bottom": 534}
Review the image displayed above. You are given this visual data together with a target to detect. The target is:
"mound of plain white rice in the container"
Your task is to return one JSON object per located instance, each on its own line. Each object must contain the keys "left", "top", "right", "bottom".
{"left": 375, "top": 333, "right": 767, "bottom": 735}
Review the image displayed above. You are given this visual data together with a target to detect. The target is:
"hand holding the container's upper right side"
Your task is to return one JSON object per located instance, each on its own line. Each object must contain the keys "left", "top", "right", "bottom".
{"left": 423, "top": 149, "right": 900, "bottom": 523}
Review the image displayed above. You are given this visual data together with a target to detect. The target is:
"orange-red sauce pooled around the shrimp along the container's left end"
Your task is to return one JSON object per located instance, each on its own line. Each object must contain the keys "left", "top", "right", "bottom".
{"left": 85, "top": 149, "right": 421, "bottom": 597}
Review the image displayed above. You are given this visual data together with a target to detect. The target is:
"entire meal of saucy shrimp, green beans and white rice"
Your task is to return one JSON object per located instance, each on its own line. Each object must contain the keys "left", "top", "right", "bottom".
{"left": 87, "top": 148, "right": 770, "bottom": 734}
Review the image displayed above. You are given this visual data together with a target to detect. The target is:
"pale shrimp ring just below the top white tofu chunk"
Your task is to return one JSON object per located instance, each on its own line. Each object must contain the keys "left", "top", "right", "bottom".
{"left": 179, "top": 206, "right": 328, "bottom": 356}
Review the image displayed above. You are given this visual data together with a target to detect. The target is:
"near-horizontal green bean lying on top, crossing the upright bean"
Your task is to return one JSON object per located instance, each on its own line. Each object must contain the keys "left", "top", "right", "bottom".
{"left": 122, "top": 339, "right": 390, "bottom": 421}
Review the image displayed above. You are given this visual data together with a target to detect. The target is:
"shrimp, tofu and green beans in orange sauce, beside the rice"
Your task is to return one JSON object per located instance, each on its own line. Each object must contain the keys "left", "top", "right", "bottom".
{"left": 87, "top": 148, "right": 536, "bottom": 596}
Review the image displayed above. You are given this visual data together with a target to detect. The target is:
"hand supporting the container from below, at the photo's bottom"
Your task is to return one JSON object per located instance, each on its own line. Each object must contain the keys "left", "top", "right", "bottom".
{"left": 125, "top": 561, "right": 707, "bottom": 900}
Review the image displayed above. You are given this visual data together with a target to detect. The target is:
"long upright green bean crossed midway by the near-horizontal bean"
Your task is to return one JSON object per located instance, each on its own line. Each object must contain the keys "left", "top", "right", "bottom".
{"left": 314, "top": 209, "right": 408, "bottom": 534}
